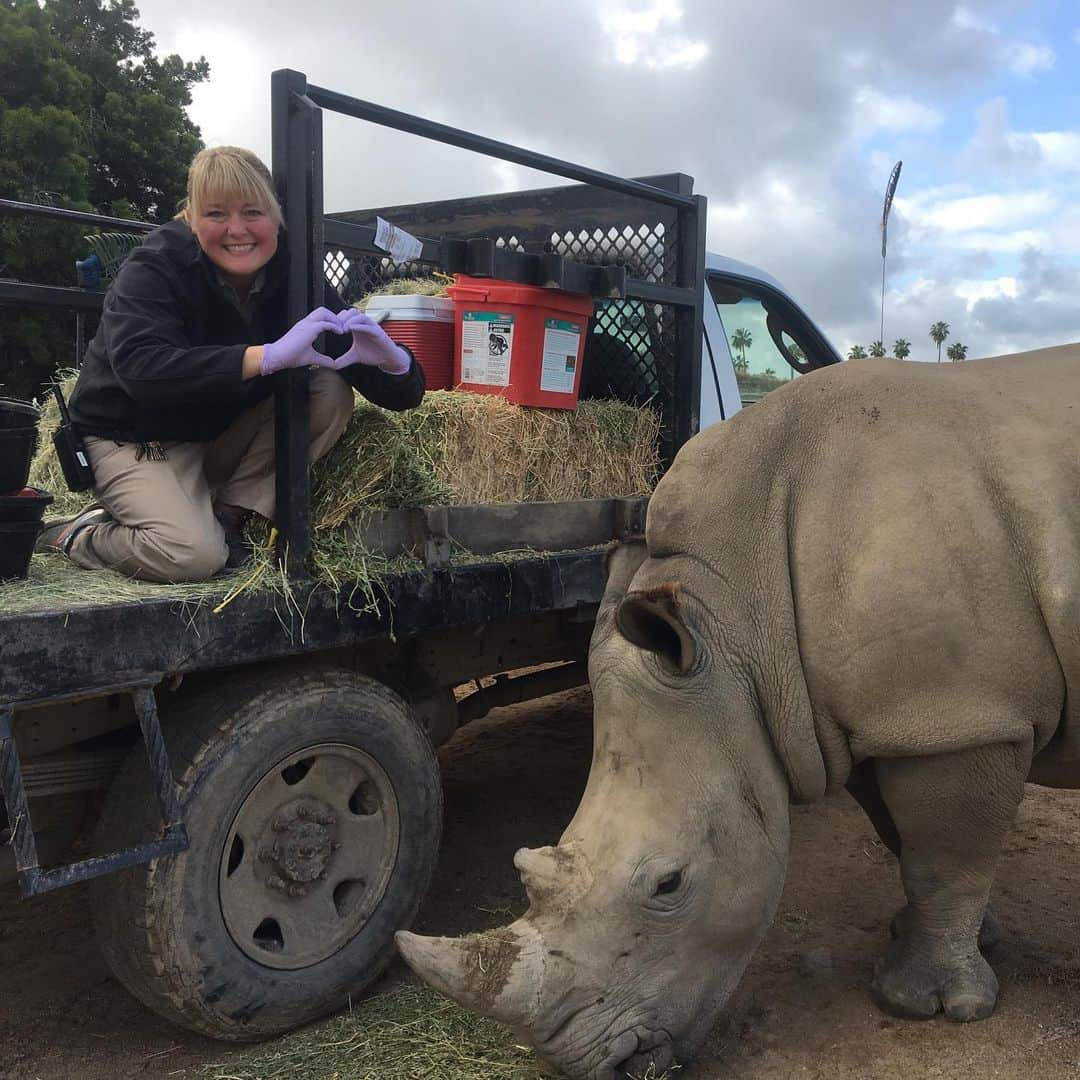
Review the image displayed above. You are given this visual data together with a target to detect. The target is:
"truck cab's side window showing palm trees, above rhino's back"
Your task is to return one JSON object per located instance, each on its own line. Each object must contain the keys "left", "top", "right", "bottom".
{"left": 708, "top": 274, "right": 834, "bottom": 405}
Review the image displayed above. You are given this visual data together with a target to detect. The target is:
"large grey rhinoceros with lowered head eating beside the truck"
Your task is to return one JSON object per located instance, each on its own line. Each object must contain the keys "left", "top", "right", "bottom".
{"left": 397, "top": 347, "right": 1080, "bottom": 1080}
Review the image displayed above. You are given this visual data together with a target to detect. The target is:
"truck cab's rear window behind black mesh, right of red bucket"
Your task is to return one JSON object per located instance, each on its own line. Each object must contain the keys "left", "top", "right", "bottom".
{"left": 581, "top": 299, "right": 661, "bottom": 405}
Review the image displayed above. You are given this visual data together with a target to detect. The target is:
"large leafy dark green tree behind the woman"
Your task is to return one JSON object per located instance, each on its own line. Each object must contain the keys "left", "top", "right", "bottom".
{"left": 0, "top": 0, "right": 210, "bottom": 395}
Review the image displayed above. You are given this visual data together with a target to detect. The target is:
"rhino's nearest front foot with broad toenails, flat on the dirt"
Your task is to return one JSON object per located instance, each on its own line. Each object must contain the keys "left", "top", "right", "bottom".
{"left": 872, "top": 913, "right": 998, "bottom": 1023}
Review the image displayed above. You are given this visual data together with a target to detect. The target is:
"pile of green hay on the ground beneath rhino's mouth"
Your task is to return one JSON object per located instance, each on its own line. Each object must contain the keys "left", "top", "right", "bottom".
{"left": 200, "top": 985, "right": 671, "bottom": 1080}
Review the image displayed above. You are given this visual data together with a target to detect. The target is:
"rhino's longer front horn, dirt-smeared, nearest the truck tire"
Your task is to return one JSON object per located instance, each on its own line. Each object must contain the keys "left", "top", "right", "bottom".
{"left": 394, "top": 920, "right": 544, "bottom": 1028}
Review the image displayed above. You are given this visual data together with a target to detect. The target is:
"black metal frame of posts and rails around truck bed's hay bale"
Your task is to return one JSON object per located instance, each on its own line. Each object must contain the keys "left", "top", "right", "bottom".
{"left": 271, "top": 69, "right": 705, "bottom": 572}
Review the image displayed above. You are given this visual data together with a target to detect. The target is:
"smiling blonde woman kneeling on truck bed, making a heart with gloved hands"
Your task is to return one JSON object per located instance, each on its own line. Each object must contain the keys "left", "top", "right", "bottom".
{"left": 38, "top": 147, "right": 424, "bottom": 582}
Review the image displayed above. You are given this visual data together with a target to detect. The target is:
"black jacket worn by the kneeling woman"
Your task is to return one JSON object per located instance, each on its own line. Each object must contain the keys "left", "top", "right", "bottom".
{"left": 70, "top": 221, "right": 424, "bottom": 443}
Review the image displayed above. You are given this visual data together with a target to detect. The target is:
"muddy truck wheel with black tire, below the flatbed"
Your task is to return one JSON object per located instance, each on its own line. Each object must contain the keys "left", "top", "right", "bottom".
{"left": 91, "top": 671, "right": 442, "bottom": 1041}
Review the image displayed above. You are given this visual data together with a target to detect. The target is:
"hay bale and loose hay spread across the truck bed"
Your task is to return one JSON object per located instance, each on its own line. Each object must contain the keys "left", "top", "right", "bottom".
{"left": 10, "top": 382, "right": 660, "bottom": 611}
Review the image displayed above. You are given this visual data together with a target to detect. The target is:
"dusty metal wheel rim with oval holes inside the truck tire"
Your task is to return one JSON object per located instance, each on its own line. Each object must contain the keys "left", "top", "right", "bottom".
{"left": 218, "top": 743, "right": 400, "bottom": 970}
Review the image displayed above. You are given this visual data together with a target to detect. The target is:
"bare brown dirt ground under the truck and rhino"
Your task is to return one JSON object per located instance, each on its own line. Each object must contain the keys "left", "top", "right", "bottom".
{"left": 0, "top": 690, "right": 1080, "bottom": 1080}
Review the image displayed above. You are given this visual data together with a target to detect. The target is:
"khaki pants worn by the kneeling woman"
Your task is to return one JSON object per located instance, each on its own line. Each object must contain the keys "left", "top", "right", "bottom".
{"left": 68, "top": 368, "right": 353, "bottom": 583}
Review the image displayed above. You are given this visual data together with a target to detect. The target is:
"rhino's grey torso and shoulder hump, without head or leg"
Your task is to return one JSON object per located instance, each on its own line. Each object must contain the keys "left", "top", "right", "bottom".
{"left": 648, "top": 347, "right": 1080, "bottom": 782}
